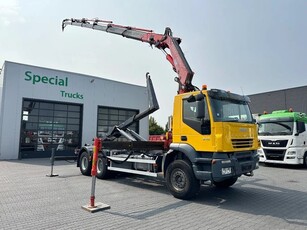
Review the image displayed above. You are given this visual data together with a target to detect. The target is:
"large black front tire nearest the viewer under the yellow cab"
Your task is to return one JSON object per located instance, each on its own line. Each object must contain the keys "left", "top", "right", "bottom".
{"left": 165, "top": 160, "right": 200, "bottom": 200}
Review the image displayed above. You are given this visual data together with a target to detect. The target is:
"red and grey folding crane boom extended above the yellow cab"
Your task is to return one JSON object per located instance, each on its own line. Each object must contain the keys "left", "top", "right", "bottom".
{"left": 62, "top": 18, "right": 197, "bottom": 94}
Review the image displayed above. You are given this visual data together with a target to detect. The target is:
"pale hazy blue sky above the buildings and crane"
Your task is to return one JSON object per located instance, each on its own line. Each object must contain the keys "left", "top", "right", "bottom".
{"left": 0, "top": 0, "right": 307, "bottom": 127}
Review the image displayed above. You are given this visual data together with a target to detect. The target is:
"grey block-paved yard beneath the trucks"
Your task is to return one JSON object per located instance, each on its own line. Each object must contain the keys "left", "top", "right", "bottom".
{"left": 0, "top": 159, "right": 307, "bottom": 230}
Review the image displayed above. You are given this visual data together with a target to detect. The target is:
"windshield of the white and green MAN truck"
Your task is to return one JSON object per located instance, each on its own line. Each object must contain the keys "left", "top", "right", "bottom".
{"left": 258, "top": 121, "right": 294, "bottom": 136}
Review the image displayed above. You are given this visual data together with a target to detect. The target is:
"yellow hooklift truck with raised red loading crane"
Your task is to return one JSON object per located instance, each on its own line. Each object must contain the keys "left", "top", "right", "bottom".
{"left": 62, "top": 18, "right": 259, "bottom": 199}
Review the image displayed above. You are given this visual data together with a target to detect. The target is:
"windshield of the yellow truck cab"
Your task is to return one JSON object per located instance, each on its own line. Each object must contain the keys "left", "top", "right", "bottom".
{"left": 210, "top": 98, "right": 253, "bottom": 123}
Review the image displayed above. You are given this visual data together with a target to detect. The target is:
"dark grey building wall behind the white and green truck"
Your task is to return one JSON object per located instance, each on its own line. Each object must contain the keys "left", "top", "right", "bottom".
{"left": 249, "top": 86, "right": 307, "bottom": 114}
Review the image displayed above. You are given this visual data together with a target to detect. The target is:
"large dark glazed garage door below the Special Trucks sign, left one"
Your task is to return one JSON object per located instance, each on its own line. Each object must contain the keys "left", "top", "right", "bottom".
{"left": 20, "top": 99, "right": 82, "bottom": 158}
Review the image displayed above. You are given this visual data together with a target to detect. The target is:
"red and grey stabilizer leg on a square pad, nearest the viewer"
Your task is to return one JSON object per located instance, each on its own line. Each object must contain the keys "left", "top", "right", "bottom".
{"left": 82, "top": 137, "right": 110, "bottom": 212}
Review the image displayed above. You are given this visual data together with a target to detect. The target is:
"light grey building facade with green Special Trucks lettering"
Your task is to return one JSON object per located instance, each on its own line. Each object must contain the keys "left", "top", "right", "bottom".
{"left": 0, "top": 61, "right": 148, "bottom": 159}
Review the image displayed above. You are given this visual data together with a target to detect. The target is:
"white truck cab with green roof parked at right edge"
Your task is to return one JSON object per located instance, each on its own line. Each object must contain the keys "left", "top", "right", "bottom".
{"left": 258, "top": 110, "right": 307, "bottom": 167}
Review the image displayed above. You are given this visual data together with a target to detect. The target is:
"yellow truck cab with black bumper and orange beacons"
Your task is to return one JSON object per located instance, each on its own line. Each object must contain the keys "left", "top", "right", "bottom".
{"left": 170, "top": 89, "right": 259, "bottom": 183}
